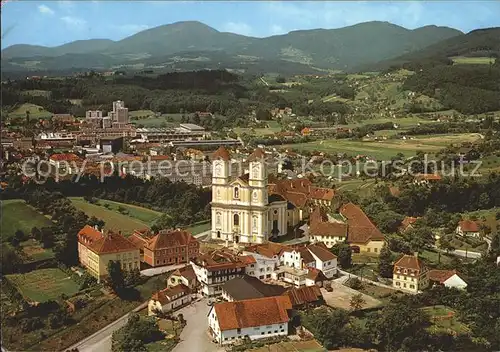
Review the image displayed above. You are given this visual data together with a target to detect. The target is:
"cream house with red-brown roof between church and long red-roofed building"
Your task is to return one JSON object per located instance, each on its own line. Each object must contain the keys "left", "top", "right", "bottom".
{"left": 309, "top": 207, "right": 347, "bottom": 248}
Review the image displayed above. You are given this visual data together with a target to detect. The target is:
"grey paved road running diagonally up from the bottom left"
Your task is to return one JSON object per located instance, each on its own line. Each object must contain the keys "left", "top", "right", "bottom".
{"left": 68, "top": 302, "right": 148, "bottom": 352}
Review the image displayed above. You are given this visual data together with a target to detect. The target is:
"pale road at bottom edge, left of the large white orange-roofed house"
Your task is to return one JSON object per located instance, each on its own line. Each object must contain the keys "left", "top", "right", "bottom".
{"left": 173, "top": 299, "right": 224, "bottom": 352}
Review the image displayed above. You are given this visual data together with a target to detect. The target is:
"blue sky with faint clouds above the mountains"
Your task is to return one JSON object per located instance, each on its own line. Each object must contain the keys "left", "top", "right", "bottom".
{"left": 1, "top": 0, "right": 500, "bottom": 49}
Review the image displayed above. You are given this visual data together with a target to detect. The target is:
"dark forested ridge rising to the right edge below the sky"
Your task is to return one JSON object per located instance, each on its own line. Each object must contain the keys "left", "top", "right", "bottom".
{"left": 362, "top": 27, "right": 500, "bottom": 70}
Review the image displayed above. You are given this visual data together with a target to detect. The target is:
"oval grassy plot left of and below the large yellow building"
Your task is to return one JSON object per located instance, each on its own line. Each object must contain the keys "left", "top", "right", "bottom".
{"left": 7, "top": 268, "right": 79, "bottom": 302}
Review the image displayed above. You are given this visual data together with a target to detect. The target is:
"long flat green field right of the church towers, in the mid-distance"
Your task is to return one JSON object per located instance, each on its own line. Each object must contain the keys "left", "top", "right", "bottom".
{"left": 283, "top": 133, "right": 479, "bottom": 160}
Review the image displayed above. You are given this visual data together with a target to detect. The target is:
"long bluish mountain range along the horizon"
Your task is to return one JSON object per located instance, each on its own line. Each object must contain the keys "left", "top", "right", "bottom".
{"left": 2, "top": 21, "right": 463, "bottom": 70}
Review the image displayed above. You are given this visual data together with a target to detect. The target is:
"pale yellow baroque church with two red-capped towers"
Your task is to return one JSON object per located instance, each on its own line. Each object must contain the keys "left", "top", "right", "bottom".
{"left": 212, "top": 147, "right": 287, "bottom": 243}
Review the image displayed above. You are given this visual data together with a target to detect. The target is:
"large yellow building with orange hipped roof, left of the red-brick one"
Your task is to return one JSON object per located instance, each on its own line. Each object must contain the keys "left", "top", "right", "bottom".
{"left": 78, "top": 225, "right": 140, "bottom": 282}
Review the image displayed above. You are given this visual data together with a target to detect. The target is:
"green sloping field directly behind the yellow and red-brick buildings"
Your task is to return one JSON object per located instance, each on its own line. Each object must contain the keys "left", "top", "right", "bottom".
{"left": 70, "top": 198, "right": 160, "bottom": 236}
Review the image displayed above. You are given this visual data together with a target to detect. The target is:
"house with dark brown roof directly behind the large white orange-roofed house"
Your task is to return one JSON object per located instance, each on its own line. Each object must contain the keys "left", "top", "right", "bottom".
{"left": 222, "top": 275, "right": 286, "bottom": 302}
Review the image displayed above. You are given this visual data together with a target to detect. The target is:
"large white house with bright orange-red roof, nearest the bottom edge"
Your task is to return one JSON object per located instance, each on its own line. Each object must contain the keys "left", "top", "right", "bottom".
{"left": 208, "top": 296, "right": 292, "bottom": 345}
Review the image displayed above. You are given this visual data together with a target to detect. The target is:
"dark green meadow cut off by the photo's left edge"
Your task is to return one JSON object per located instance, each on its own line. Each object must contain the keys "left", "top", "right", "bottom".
{"left": 1, "top": 199, "right": 53, "bottom": 241}
